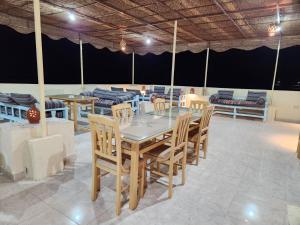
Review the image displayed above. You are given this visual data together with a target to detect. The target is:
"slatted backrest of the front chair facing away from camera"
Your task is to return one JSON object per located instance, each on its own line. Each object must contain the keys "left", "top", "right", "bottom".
{"left": 88, "top": 114, "right": 122, "bottom": 168}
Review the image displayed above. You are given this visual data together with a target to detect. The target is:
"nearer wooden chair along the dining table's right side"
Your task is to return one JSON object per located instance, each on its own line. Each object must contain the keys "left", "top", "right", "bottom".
{"left": 143, "top": 113, "right": 192, "bottom": 198}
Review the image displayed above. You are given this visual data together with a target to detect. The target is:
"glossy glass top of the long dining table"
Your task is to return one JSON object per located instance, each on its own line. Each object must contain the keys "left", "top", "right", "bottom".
{"left": 120, "top": 107, "right": 201, "bottom": 142}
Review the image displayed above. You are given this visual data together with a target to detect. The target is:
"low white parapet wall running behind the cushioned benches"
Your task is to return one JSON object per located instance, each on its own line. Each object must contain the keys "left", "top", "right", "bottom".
{"left": 0, "top": 84, "right": 300, "bottom": 123}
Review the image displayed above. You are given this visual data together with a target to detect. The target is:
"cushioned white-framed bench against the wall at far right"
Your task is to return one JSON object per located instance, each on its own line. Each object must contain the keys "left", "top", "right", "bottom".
{"left": 209, "top": 90, "right": 268, "bottom": 121}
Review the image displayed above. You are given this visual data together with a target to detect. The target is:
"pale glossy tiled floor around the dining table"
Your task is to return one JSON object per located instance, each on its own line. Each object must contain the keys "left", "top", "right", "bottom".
{"left": 0, "top": 117, "right": 300, "bottom": 225}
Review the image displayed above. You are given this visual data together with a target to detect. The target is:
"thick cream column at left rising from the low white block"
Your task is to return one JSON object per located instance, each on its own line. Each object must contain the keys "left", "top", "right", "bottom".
{"left": 33, "top": 0, "right": 47, "bottom": 137}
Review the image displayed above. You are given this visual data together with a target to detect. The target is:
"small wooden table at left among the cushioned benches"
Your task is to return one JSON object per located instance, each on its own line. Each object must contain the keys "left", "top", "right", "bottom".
{"left": 47, "top": 94, "right": 98, "bottom": 131}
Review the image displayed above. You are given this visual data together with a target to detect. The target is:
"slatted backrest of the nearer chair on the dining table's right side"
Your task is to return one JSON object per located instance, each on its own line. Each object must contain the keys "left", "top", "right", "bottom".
{"left": 171, "top": 113, "right": 192, "bottom": 150}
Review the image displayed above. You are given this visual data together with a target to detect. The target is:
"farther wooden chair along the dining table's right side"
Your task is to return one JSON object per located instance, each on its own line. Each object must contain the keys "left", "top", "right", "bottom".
{"left": 188, "top": 106, "right": 214, "bottom": 165}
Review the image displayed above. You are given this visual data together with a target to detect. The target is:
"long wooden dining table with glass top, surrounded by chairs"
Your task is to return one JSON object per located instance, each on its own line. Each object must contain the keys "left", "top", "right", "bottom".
{"left": 120, "top": 107, "right": 201, "bottom": 209}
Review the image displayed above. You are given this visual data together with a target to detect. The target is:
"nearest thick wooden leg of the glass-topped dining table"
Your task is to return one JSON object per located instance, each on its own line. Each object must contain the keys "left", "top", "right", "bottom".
{"left": 129, "top": 143, "right": 139, "bottom": 210}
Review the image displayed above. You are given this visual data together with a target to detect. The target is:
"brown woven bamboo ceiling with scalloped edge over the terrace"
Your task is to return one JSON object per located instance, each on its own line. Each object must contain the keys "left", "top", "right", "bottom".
{"left": 0, "top": 0, "right": 300, "bottom": 53}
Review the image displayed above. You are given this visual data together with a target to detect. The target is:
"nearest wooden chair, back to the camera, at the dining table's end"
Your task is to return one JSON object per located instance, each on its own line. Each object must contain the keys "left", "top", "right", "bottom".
{"left": 88, "top": 114, "right": 145, "bottom": 215}
